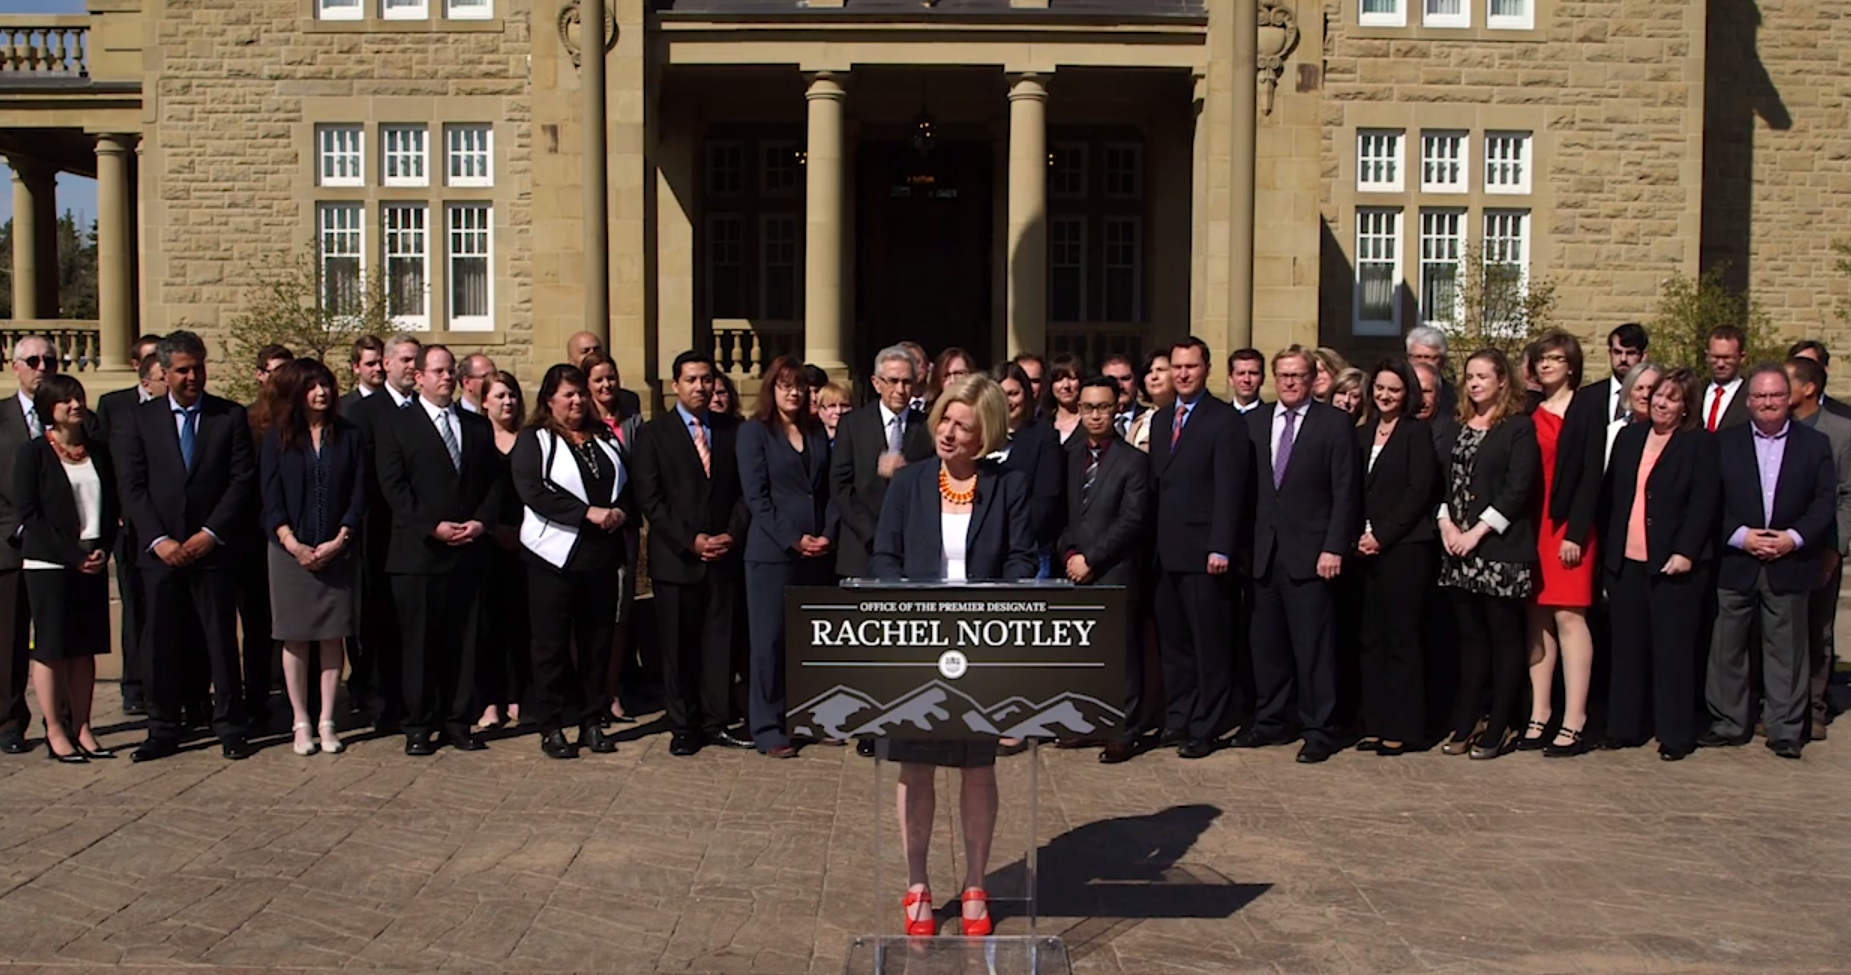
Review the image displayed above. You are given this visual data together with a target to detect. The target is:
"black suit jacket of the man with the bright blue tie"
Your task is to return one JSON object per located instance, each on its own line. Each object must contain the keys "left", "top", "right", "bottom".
{"left": 117, "top": 392, "right": 257, "bottom": 568}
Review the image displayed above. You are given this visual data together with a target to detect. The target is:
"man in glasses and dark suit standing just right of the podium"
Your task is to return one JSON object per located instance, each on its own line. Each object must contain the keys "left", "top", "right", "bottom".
{"left": 1055, "top": 376, "right": 1151, "bottom": 764}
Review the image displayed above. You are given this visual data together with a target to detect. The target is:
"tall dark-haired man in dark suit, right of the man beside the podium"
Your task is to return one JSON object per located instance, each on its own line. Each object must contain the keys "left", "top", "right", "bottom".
{"left": 1149, "top": 337, "right": 1253, "bottom": 759}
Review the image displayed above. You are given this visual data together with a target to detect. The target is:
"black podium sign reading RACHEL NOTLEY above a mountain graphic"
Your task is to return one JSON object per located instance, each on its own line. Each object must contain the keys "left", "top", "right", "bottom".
{"left": 785, "top": 583, "right": 1127, "bottom": 738}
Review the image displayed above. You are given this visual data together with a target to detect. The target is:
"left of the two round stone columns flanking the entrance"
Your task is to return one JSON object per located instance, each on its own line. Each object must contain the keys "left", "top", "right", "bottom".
{"left": 803, "top": 70, "right": 850, "bottom": 379}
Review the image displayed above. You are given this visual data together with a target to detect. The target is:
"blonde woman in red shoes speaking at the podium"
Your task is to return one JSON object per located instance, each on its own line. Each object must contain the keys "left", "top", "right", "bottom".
{"left": 870, "top": 374, "right": 1035, "bottom": 936}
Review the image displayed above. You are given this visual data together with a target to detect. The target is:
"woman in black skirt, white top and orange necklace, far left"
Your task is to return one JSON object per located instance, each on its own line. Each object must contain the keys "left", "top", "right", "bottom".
{"left": 13, "top": 374, "right": 120, "bottom": 764}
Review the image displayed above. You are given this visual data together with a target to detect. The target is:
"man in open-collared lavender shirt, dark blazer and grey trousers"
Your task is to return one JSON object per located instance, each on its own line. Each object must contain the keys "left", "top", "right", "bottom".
{"left": 1697, "top": 368, "right": 1838, "bottom": 759}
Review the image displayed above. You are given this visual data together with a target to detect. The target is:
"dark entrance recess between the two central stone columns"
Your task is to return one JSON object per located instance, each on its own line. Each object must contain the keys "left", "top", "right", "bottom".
{"left": 855, "top": 141, "right": 992, "bottom": 374}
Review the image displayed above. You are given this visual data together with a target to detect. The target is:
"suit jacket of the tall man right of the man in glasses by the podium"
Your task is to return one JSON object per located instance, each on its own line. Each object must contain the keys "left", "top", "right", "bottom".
{"left": 1149, "top": 392, "right": 1253, "bottom": 572}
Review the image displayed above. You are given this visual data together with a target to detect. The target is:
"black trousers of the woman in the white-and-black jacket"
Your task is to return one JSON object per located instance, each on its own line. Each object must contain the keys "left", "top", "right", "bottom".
{"left": 522, "top": 561, "right": 618, "bottom": 733}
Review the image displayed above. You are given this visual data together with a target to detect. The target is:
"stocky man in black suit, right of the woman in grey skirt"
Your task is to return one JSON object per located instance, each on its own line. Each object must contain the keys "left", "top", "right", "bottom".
{"left": 374, "top": 346, "right": 507, "bottom": 755}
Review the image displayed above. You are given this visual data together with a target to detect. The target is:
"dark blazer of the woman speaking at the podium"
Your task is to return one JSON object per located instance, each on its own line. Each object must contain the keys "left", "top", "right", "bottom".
{"left": 868, "top": 461, "right": 1038, "bottom": 583}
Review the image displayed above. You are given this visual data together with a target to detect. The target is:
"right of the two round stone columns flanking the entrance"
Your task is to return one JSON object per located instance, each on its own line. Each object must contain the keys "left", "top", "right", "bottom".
{"left": 1007, "top": 74, "right": 1048, "bottom": 355}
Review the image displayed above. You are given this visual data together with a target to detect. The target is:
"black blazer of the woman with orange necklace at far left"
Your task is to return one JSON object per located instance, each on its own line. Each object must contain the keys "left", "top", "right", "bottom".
{"left": 7, "top": 437, "right": 122, "bottom": 568}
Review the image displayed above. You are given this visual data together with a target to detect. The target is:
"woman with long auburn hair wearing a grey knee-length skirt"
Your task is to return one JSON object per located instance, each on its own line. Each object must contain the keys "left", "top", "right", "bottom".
{"left": 257, "top": 359, "right": 366, "bottom": 755}
